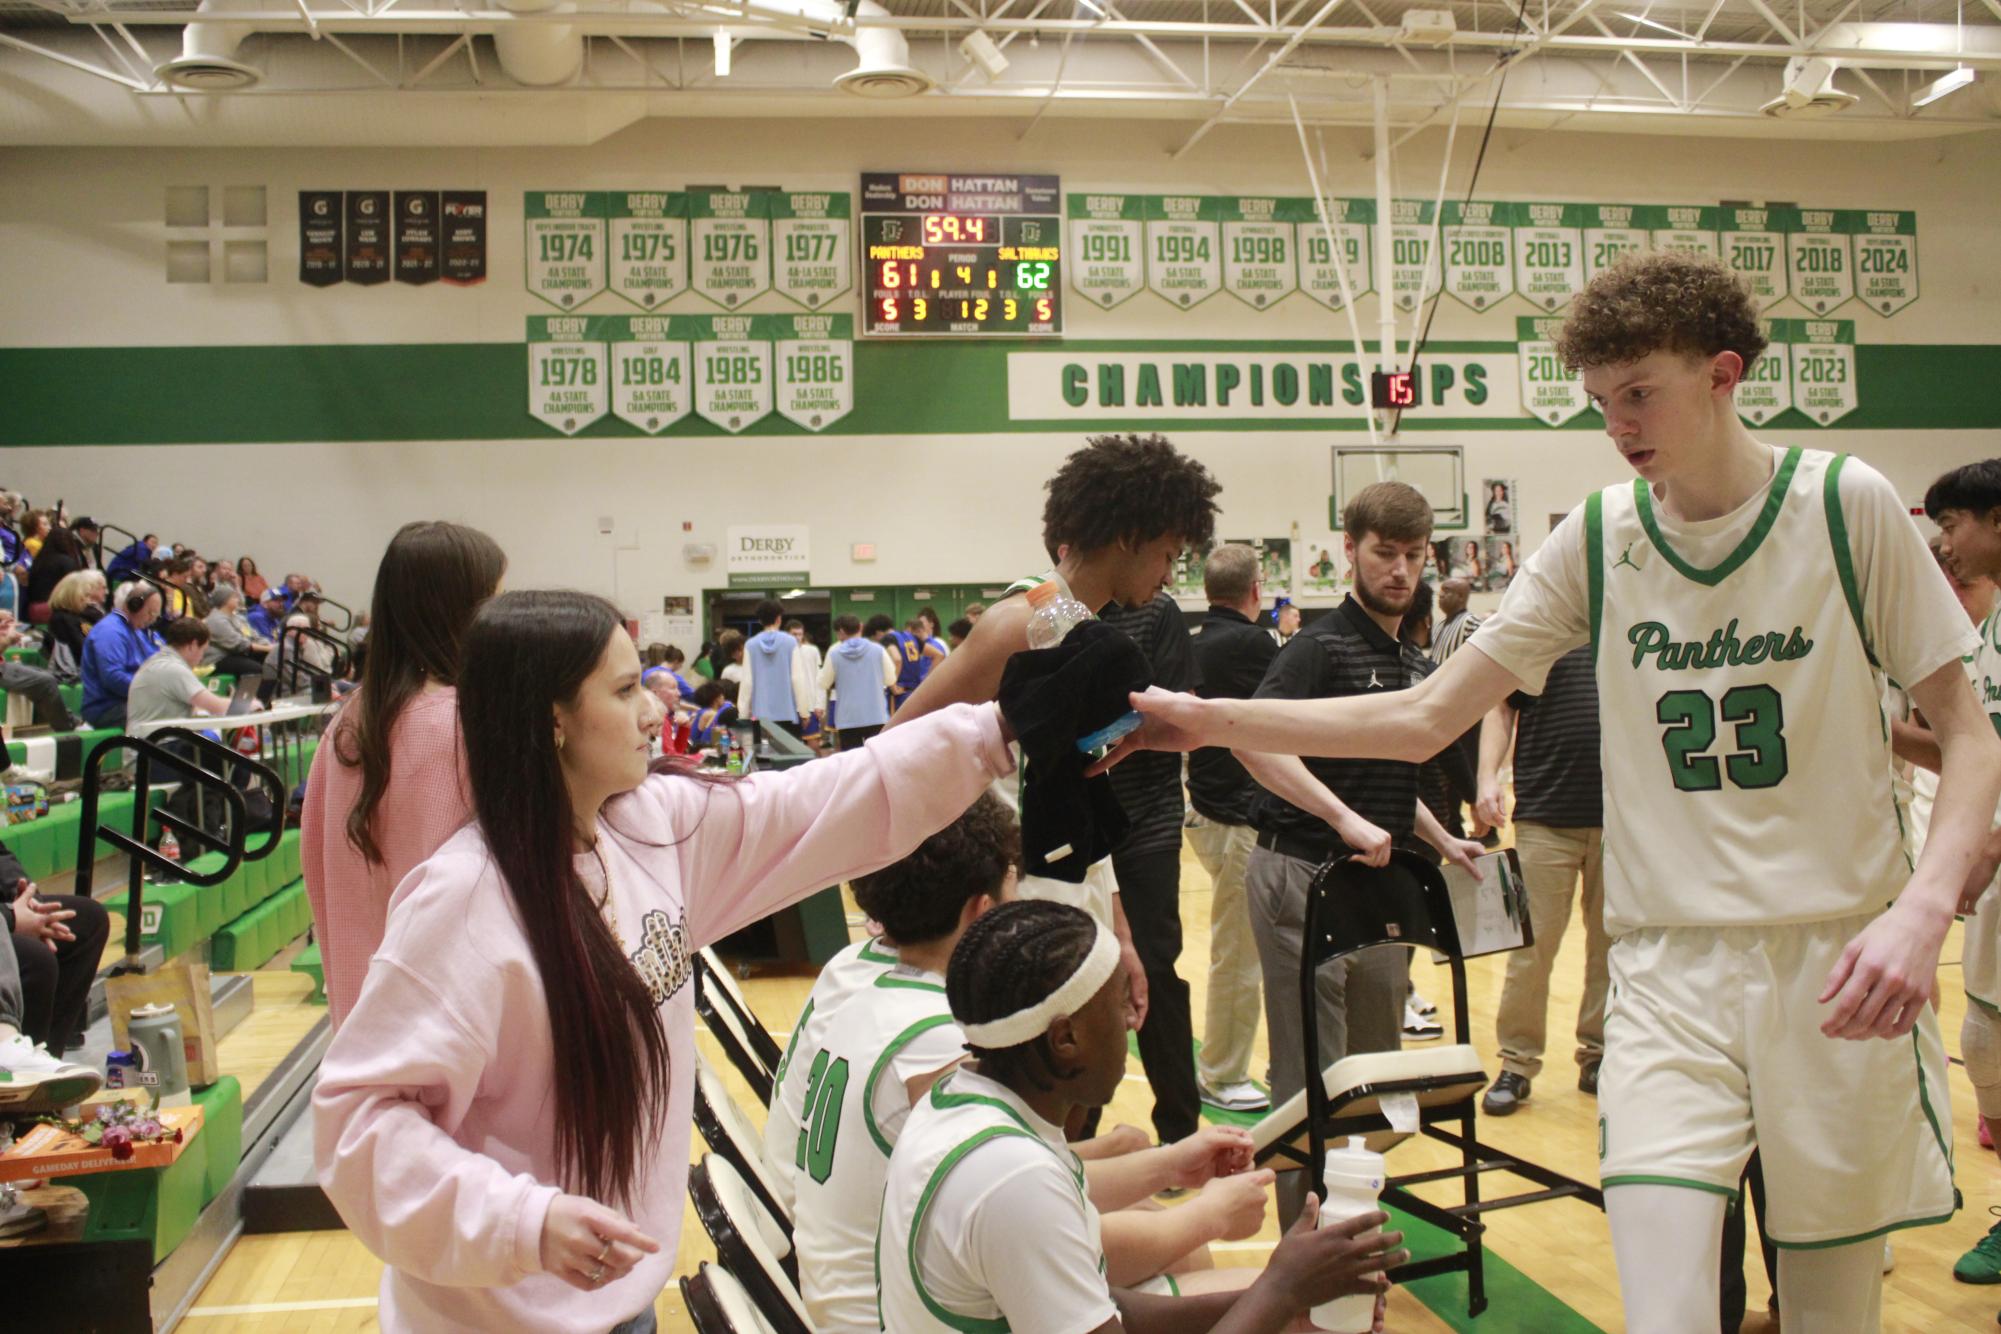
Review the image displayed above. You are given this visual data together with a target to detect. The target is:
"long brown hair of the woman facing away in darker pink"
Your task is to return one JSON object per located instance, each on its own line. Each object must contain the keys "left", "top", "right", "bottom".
{"left": 336, "top": 522, "right": 506, "bottom": 864}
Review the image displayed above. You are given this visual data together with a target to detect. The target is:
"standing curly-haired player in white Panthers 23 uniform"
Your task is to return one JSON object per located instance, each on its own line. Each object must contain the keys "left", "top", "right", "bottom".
{"left": 1088, "top": 252, "right": 2001, "bottom": 1334}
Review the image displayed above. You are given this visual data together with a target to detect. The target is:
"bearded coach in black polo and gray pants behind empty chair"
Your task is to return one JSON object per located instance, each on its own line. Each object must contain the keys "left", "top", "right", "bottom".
{"left": 1241, "top": 482, "right": 1481, "bottom": 1226}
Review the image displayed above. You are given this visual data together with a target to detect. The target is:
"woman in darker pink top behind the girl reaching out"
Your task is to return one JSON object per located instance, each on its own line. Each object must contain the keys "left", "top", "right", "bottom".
{"left": 300, "top": 522, "right": 506, "bottom": 1028}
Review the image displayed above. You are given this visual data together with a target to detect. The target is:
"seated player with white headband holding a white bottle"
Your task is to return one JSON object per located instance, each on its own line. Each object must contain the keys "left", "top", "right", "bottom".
{"left": 876, "top": 900, "right": 1403, "bottom": 1334}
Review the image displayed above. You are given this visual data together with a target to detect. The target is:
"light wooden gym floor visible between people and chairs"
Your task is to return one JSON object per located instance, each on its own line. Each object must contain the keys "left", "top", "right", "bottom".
{"left": 168, "top": 852, "right": 2001, "bottom": 1334}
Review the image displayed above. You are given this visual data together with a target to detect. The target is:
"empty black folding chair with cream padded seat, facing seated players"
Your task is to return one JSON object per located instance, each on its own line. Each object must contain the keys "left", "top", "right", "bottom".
{"left": 1255, "top": 852, "right": 1605, "bottom": 1316}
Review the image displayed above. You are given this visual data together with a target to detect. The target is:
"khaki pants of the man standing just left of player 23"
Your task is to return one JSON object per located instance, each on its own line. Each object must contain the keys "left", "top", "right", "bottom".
{"left": 1495, "top": 822, "right": 1607, "bottom": 1080}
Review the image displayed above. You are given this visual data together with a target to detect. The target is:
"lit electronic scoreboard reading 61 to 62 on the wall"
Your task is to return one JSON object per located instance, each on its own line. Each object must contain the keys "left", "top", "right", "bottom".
{"left": 862, "top": 172, "right": 1063, "bottom": 338}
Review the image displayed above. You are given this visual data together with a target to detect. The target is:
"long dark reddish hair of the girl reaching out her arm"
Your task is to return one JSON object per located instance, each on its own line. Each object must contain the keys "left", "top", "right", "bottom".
{"left": 454, "top": 592, "right": 668, "bottom": 1206}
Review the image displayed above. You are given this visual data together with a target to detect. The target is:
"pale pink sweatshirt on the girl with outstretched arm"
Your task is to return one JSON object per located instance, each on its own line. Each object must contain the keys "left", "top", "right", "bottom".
{"left": 312, "top": 704, "right": 1013, "bottom": 1334}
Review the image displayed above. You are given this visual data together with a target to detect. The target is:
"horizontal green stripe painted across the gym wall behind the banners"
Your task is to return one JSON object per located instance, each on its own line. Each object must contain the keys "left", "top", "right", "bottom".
{"left": 0, "top": 340, "right": 2001, "bottom": 446}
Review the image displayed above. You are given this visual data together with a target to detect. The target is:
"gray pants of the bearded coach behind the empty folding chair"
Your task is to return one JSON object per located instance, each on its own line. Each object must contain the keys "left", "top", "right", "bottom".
{"left": 1245, "top": 848, "right": 1411, "bottom": 1228}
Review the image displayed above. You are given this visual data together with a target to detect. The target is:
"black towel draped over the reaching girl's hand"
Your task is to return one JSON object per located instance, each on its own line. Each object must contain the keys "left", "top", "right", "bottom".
{"left": 1001, "top": 620, "right": 1151, "bottom": 884}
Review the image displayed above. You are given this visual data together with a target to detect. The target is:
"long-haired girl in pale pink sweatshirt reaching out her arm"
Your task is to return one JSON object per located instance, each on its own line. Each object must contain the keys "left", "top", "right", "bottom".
{"left": 314, "top": 592, "right": 1011, "bottom": 1334}
